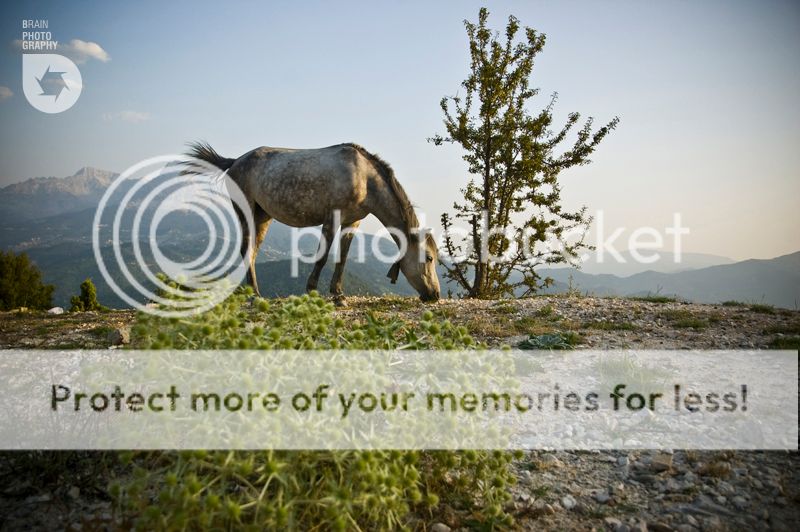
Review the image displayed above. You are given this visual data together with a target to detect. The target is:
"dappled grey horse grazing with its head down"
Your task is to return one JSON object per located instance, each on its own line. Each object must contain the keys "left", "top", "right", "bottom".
{"left": 188, "top": 142, "right": 439, "bottom": 304}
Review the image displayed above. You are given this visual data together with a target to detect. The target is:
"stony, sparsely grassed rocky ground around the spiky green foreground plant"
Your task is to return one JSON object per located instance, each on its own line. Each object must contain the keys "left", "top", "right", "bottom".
{"left": 0, "top": 297, "right": 800, "bottom": 532}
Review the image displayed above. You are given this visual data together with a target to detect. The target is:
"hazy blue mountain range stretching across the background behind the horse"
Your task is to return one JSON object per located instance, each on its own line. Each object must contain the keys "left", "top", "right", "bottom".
{"left": 0, "top": 167, "right": 800, "bottom": 308}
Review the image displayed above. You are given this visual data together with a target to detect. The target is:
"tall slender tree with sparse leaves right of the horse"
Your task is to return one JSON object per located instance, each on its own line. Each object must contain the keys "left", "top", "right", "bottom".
{"left": 429, "top": 8, "right": 619, "bottom": 297}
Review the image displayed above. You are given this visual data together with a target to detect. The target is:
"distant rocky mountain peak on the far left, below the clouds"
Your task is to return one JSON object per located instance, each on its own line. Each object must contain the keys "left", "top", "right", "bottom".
{"left": 0, "top": 166, "right": 119, "bottom": 223}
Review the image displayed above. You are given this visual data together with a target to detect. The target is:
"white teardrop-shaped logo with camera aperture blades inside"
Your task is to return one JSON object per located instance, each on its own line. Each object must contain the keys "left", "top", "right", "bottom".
{"left": 22, "top": 54, "right": 83, "bottom": 114}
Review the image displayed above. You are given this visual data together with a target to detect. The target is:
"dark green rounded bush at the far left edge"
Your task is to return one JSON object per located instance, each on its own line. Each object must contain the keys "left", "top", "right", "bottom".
{"left": 0, "top": 251, "right": 55, "bottom": 310}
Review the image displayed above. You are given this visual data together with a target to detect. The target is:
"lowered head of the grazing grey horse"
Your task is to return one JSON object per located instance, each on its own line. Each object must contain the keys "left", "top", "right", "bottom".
{"left": 387, "top": 233, "right": 439, "bottom": 301}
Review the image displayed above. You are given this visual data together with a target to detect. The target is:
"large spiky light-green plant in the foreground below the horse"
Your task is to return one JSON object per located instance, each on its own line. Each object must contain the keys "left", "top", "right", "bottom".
{"left": 122, "top": 291, "right": 515, "bottom": 530}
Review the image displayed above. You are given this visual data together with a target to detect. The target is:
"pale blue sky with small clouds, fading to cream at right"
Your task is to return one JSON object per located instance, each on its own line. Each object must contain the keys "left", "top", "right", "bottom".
{"left": 0, "top": 0, "right": 800, "bottom": 259}
